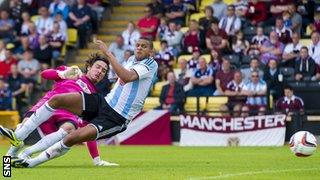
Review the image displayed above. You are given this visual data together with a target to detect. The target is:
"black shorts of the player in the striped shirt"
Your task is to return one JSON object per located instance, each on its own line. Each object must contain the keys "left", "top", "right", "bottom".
{"left": 80, "top": 92, "right": 129, "bottom": 139}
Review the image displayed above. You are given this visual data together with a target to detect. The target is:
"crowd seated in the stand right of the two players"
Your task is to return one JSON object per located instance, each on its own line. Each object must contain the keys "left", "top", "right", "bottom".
{"left": 123, "top": 0, "right": 320, "bottom": 115}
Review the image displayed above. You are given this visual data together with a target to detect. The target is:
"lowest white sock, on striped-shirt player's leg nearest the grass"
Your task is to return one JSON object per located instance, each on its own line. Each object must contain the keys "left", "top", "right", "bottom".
{"left": 26, "top": 140, "right": 70, "bottom": 167}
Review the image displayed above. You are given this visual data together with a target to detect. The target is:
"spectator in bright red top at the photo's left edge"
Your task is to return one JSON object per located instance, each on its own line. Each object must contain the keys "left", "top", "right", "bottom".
{"left": 0, "top": 45, "right": 18, "bottom": 78}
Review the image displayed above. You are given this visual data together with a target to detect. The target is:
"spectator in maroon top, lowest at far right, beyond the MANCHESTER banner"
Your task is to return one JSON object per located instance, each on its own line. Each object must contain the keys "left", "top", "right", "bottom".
{"left": 276, "top": 85, "right": 304, "bottom": 115}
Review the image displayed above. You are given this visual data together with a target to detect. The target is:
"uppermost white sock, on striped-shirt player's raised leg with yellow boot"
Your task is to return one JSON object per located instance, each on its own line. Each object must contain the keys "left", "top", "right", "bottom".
{"left": 15, "top": 102, "right": 54, "bottom": 141}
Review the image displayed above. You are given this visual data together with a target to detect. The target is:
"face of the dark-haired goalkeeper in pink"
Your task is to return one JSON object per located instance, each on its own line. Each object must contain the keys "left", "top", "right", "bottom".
{"left": 87, "top": 61, "right": 108, "bottom": 83}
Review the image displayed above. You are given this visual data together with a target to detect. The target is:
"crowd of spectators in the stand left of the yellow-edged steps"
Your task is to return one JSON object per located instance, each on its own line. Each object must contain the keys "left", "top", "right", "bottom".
{"left": 0, "top": 0, "right": 104, "bottom": 115}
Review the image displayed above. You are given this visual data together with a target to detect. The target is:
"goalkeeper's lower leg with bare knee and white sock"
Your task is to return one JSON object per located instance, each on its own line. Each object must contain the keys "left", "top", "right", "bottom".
{"left": 18, "top": 121, "right": 76, "bottom": 159}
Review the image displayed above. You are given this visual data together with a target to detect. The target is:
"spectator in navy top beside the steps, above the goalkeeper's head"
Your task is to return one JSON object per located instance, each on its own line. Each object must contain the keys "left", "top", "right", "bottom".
{"left": 68, "top": 0, "right": 91, "bottom": 49}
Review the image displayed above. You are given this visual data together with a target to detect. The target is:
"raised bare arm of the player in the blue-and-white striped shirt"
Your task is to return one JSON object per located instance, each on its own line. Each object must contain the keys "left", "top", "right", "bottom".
{"left": 96, "top": 40, "right": 139, "bottom": 83}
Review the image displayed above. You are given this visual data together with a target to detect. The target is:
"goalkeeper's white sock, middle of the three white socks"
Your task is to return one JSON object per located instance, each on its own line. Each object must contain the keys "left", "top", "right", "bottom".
{"left": 18, "top": 128, "right": 68, "bottom": 159}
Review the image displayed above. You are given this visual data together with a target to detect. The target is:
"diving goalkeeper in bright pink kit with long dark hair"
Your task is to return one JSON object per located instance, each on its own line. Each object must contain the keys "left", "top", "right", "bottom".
{"left": 0, "top": 54, "right": 117, "bottom": 166}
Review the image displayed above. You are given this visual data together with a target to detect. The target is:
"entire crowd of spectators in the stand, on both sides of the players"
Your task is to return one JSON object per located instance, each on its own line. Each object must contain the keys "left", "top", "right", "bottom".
{"left": 0, "top": 0, "right": 320, "bottom": 118}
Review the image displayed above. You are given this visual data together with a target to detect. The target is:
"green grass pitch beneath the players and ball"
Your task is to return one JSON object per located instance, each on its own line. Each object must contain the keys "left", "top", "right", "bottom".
{"left": 0, "top": 145, "right": 320, "bottom": 180}
